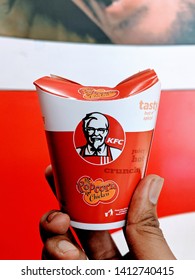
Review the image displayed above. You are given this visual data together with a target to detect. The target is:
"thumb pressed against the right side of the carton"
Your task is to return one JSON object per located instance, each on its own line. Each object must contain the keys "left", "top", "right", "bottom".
{"left": 126, "top": 175, "right": 175, "bottom": 260}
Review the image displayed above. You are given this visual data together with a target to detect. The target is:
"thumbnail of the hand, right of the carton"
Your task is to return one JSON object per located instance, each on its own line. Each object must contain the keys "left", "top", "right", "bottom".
{"left": 149, "top": 176, "right": 164, "bottom": 205}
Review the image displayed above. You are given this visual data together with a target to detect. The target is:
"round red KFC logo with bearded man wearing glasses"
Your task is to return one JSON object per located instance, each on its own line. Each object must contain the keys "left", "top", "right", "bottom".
{"left": 74, "top": 112, "right": 125, "bottom": 165}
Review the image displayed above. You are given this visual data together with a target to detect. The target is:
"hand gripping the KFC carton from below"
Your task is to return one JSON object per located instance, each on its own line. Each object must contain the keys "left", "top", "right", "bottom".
{"left": 40, "top": 167, "right": 175, "bottom": 260}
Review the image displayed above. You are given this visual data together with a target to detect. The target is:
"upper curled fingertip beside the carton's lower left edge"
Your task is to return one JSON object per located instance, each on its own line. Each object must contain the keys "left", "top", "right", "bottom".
{"left": 39, "top": 210, "right": 70, "bottom": 242}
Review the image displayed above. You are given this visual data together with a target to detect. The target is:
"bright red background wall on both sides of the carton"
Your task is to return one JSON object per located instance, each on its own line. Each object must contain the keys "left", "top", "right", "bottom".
{"left": 0, "top": 90, "right": 195, "bottom": 260}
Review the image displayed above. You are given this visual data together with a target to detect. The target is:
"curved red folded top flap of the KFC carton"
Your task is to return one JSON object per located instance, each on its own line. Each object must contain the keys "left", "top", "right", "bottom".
{"left": 34, "top": 69, "right": 159, "bottom": 101}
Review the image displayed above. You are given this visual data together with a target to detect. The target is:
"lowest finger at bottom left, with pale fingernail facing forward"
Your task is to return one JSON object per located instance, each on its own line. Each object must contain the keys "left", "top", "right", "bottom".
{"left": 42, "top": 235, "right": 87, "bottom": 260}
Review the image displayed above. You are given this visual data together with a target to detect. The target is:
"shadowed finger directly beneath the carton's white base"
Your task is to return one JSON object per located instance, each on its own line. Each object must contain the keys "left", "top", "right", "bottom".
{"left": 75, "top": 229, "right": 121, "bottom": 260}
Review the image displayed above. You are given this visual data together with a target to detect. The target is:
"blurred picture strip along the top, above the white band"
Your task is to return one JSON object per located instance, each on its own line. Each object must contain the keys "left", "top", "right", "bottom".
{"left": 0, "top": 0, "right": 195, "bottom": 45}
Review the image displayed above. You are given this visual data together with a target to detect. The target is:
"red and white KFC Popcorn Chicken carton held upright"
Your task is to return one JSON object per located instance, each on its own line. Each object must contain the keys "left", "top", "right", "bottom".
{"left": 34, "top": 69, "right": 160, "bottom": 230}
